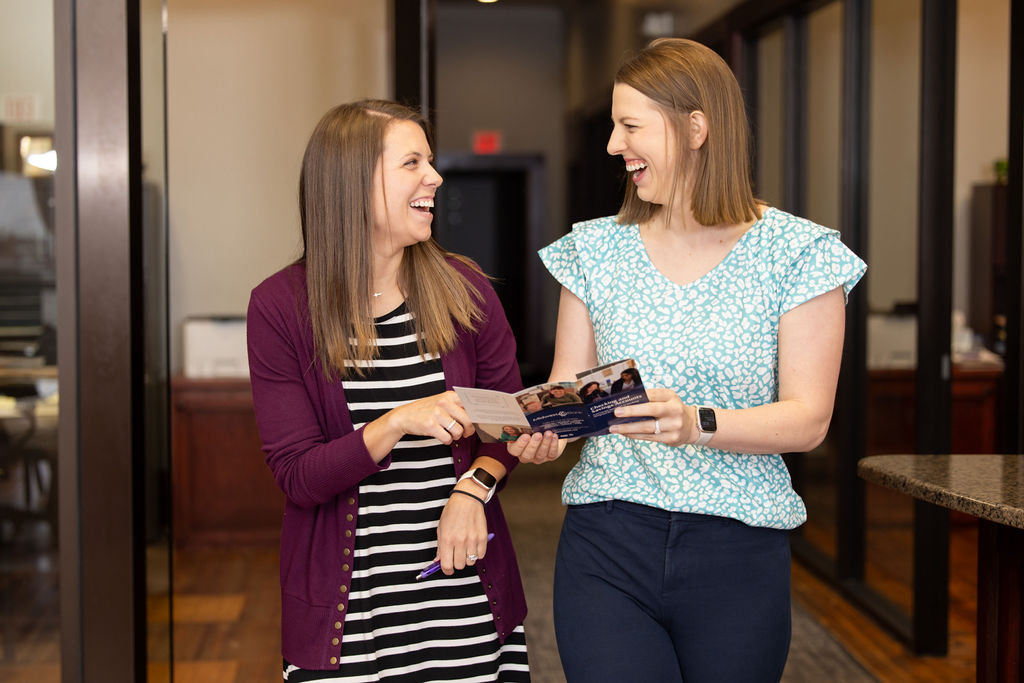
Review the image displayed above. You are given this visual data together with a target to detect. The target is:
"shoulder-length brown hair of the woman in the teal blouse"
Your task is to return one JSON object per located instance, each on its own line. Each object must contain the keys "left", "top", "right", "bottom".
{"left": 615, "top": 38, "right": 760, "bottom": 225}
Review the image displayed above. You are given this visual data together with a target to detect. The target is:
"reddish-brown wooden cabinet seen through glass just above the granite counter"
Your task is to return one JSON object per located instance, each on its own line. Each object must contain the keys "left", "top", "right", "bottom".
{"left": 867, "top": 366, "right": 1002, "bottom": 456}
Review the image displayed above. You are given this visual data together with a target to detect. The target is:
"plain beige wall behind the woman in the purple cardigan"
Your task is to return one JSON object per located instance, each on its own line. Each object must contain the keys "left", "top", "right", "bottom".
{"left": 167, "top": 0, "right": 391, "bottom": 372}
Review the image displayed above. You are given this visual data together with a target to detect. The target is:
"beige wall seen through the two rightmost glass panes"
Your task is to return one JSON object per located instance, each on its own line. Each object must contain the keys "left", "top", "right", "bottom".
{"left": 868, "top": 0, "right": 1010, "bottom": 311}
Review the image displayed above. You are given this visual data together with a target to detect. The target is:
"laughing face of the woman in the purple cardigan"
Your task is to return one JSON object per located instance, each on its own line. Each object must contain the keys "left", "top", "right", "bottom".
{"left": 374, "top": 121, "right": 441, "bottom": 252}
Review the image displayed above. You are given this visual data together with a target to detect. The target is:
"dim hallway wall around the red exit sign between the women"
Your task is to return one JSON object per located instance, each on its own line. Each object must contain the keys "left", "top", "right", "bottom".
{"left": 436, "top": 3, "right": 569, "bottom": 344}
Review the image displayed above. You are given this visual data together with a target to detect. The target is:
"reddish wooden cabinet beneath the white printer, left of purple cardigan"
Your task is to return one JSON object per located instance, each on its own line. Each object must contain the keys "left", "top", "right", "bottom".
{"left": 171, "top": 378, "right": 285, "bottom": 546}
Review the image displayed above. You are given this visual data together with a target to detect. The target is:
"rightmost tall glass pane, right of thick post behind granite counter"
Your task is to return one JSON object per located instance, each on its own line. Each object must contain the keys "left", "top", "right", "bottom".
{"left": 949, "top": 0, "right": 1011, "bottom": 653}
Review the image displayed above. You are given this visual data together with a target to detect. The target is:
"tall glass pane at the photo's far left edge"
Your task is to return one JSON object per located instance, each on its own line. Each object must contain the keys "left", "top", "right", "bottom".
{"left": 0, "top": 2, "right": 60, "bottom": 682}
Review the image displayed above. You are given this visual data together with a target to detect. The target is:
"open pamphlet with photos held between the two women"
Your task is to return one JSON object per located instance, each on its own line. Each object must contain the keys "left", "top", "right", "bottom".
{"left": 453, "top": 358, "right": 648, "bottom": 442}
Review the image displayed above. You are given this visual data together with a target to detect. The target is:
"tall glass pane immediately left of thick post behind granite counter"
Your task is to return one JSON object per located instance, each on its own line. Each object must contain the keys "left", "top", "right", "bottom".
{"left": 864, "top": 0, "right": 922, "bottom": 614}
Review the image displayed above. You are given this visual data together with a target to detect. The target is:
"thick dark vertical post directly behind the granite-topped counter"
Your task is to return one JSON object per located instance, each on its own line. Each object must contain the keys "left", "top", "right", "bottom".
{"left": 911, "top": 0, "right": 956, "bottom": 655}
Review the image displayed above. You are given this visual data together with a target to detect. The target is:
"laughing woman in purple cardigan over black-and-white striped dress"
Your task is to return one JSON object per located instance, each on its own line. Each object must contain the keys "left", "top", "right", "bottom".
{"left": 248, "top": 100, "right": 529, "bottom": 682}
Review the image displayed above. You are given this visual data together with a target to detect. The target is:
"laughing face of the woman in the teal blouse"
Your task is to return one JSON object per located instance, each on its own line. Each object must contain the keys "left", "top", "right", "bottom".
{"left": 607, "top": 83, "right": 678, "bottom": 205}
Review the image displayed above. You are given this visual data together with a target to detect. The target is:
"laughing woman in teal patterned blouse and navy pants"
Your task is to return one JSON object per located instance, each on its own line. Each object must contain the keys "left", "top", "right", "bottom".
{"left": 509, "top": 39, "right": 866, "bottom": 683}
